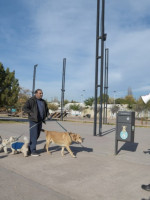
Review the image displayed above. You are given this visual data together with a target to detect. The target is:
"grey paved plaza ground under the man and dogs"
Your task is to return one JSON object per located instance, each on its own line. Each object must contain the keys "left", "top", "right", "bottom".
{"left": 0, "top": 121, "right": 150, "bottom": 200}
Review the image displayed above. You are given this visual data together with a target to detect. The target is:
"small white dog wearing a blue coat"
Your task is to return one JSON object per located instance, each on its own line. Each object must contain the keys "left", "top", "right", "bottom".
{"left": 11, "top": 137, "right": 29, "bottom": 157}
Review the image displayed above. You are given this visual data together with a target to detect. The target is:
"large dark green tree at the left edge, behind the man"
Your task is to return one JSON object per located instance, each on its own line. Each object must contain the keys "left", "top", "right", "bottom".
{"left": 0, "top": 63, "right": 20, "bottom": 109}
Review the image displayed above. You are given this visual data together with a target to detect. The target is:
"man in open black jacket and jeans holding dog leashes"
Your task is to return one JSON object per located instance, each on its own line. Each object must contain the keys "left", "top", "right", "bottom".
{"left": 23, "top": 89, "right": 49, "bottom": 156}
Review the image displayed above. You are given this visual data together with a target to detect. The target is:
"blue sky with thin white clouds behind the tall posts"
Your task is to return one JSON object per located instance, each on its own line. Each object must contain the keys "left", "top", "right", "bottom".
{"left": 0, "top": 0, "right": 150, "bottom": 101}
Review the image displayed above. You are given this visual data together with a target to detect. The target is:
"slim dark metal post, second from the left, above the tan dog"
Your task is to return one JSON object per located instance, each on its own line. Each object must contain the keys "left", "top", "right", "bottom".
{"left": 61, "top": 58, "right": 66, "bottom": 121}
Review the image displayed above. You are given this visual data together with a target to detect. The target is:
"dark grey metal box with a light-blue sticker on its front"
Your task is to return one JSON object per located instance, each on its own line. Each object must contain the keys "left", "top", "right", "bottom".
{"left": 116, "top": 111, "right": 135, "bottom": 142}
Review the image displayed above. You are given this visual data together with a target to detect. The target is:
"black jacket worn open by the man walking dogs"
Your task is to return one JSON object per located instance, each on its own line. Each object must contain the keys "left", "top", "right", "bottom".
{"left": 23, "top": 96, "right": 49, "bottom": 122}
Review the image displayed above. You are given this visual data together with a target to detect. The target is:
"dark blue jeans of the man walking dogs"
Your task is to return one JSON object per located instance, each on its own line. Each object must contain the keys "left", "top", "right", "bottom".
{"left": 29, "top": 121, "right": 42, "bottom": 153}
